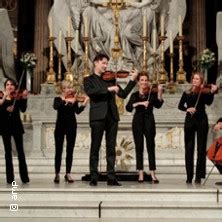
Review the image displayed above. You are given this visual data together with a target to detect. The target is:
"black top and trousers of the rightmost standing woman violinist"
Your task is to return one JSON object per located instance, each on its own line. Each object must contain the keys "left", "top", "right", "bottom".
{"left": 178, "top": 91, "right": 214, "bottom": 181}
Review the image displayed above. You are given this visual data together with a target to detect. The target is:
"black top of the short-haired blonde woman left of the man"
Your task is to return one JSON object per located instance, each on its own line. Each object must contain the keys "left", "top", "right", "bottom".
{"left": 53, "top": 97, "right": 85, "bottom": 132}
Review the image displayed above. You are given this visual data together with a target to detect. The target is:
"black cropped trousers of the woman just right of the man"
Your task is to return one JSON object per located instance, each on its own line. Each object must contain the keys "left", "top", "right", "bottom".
{"left": 133, "top": 114, "right": 156, "bottom": 170}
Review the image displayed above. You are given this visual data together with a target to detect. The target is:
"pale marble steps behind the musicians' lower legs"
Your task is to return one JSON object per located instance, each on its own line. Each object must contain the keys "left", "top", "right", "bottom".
{"left": 0, "top": 156, "right": 221, "bottom": 180}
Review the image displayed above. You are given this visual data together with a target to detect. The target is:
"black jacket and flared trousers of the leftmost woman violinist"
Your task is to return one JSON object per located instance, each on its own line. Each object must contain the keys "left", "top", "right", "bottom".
{"left": 0, "top": 99, "right": 29, "bottom": 183}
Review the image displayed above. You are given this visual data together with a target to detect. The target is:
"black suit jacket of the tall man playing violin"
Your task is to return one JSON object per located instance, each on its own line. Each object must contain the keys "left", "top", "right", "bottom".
{"left": 84, "top": 74, "right": 136, "bottom": 121}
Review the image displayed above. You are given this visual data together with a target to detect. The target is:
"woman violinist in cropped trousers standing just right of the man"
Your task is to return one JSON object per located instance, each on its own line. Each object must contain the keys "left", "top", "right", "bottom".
{"left": 126, "top": 73, "right": 163, "bottom": 183}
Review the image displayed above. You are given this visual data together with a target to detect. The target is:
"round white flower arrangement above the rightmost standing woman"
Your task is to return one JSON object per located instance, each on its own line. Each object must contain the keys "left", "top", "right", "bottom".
{"left": 199, "top": 49, "right": 216, "bottom": 69}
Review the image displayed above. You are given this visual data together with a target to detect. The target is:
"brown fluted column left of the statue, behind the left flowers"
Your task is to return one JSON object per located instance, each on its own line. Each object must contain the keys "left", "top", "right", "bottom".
{"left": 33, "top": 0, "right": 52, "bottom": 93}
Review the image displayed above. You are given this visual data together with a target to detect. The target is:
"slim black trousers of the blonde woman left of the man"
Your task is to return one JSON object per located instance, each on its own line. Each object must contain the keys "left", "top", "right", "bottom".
{"left": 54, "top": 129, "right": 76, "bottom": 174}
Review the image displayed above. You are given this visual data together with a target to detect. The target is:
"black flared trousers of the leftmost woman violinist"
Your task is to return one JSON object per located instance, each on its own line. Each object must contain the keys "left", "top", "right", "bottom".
{"left": 2, "top": 134, "right": 29, "bottom": 183}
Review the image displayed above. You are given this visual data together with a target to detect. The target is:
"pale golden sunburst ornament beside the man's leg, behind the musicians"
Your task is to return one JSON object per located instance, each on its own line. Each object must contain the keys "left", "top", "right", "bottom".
{"left": 116, "top": 138, "right": 133, "bottom": 170}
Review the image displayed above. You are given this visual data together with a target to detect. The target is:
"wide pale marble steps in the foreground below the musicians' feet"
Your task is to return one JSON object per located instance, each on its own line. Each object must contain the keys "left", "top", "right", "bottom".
{"left": 0, "top": 179, "right": 222, "bottom": 219}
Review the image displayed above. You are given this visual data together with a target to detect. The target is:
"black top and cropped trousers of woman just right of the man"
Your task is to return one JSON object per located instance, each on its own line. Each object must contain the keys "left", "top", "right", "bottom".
{"left": 126, "top": 91, "right": 163, "bottom": 170}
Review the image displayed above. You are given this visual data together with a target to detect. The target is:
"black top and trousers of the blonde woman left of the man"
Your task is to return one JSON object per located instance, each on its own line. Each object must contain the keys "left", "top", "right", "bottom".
{"left": 53, "top": 97, "right": 85, "bottom": 173}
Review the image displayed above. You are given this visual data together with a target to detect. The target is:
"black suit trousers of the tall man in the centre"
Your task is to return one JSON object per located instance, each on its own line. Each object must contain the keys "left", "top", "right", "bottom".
{"left": 90, "top": 112, "right": 118, "bottom": 180}
